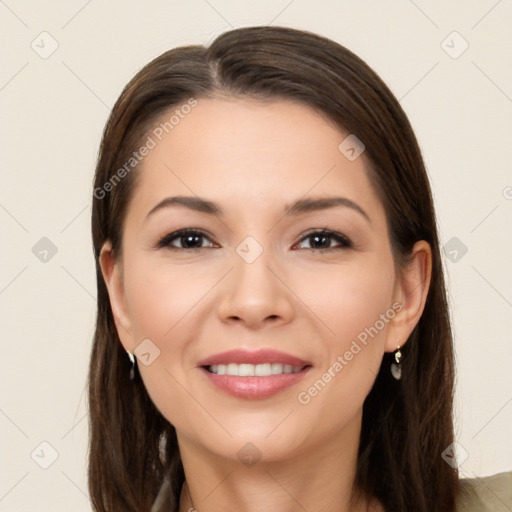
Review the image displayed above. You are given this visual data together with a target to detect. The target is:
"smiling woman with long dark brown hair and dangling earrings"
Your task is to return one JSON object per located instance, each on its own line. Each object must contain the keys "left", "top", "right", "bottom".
{"left": 89, "top": 27, "right": 512, "bottom": 512}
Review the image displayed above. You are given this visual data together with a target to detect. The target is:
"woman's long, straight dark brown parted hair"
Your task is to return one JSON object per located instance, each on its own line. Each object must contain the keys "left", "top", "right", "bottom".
{"left": 88, "top": 26, "right": 458, "bottom": 512}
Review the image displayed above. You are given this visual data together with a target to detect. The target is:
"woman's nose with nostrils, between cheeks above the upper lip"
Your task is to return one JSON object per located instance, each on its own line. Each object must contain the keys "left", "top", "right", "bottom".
{"left": 218, "top": 247, "right": 295, "bottom": 329}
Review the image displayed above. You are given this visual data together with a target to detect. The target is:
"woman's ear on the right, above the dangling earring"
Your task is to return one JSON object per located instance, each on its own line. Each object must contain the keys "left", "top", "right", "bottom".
{"left": 385, "top": 240, "right": 432, "bottom": 352}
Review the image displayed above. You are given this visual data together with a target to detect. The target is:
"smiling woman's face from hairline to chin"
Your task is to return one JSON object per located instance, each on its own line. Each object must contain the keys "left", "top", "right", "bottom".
{"left": 104, "top": 98, "right": 414, "bottom": 460}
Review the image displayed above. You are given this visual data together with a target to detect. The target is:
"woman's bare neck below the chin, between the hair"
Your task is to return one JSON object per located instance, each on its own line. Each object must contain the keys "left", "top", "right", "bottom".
{"left": 178, "top": 410, "right": 382, "bottom": 512}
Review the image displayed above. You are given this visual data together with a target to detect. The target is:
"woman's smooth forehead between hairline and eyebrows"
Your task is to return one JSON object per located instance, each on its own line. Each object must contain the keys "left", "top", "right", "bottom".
{"left": 126, "top": 98, "right": 382, "bottom": 228}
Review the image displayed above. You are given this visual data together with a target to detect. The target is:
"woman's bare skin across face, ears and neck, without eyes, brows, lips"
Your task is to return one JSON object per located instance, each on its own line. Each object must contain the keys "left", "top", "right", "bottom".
{"left": 100, "top": 97, "right": 431, "bottom": 512}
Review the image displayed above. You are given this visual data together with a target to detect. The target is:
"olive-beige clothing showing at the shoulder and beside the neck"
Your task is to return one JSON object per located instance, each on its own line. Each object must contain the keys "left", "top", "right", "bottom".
{"left": 151, "top": 471, "right": 512, "bottom": 512}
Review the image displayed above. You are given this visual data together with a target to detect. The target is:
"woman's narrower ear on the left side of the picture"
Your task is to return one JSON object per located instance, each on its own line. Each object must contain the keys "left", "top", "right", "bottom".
{"left": 99, "top": 240, "right": 135, "bottom": 353}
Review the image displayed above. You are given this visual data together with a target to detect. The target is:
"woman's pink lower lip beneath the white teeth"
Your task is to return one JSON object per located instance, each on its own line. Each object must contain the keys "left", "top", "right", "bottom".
{"left": 200, "top": 366, "right": 311, "bottom": 400}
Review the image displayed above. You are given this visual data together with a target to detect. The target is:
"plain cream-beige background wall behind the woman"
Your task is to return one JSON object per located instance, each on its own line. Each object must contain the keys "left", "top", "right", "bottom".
{"left": 0, "top": 0, "right": 512, "bottom": 512}
